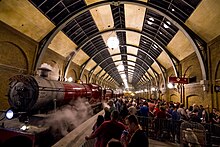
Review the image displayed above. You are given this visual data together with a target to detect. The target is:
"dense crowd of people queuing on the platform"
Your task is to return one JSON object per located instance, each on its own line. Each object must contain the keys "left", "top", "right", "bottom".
{"left": 85, "top": 98, "right": 220, "bottom": 147}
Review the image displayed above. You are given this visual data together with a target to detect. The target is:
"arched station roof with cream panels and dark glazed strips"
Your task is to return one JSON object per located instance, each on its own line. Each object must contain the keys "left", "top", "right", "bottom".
{"left": 0, "top": 0, "right": 220, "bottom": 88}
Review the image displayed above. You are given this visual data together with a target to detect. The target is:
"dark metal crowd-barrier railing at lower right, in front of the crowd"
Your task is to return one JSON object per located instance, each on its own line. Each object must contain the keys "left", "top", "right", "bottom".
{"left": 138, "top": 116, "right": 220, "bottom": 147}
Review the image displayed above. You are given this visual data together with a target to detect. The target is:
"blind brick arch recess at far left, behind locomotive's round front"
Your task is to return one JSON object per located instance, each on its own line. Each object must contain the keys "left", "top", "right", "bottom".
{"left": 0, "top": 41, "right": 29, "bottom": 109}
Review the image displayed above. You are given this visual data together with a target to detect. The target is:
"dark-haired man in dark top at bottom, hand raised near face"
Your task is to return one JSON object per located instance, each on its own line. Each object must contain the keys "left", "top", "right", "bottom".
{"left": 121, "top": 115, "right": 149, "bottom": 147}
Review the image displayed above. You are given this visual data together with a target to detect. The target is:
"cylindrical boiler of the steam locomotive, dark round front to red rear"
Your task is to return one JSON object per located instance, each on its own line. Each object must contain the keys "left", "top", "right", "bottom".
{"left": 8, "top": 75, "right": 108, "bottom": 112}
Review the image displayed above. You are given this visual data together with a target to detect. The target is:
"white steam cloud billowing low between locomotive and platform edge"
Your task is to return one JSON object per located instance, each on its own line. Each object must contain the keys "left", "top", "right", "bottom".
{"left": 45, "top": 98, "right": 92, "bottom": 138}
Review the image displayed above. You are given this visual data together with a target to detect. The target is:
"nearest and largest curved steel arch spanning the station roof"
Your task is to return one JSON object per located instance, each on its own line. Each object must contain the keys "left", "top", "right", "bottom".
{"left": 32, "top": 0, "right": 207, "bottom": 87}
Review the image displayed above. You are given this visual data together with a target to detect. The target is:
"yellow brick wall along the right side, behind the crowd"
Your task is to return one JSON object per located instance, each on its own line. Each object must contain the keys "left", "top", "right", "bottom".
{"left": 160, "top": 36, "right": 220, "bottom": 109}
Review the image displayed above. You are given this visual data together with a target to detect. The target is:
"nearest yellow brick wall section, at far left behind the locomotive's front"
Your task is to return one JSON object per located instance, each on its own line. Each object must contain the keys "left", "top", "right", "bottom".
{"left": 0, "top": 21, "right": 37, "bottom": 110}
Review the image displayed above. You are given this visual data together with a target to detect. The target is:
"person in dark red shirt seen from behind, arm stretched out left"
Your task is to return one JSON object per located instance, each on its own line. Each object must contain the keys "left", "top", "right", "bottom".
{"left": 85, "top": 110, "right": 126, "bottom": 147}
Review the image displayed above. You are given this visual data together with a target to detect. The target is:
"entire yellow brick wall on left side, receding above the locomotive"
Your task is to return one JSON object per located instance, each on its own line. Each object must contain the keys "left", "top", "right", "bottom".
{"left": 0, "top": 21, "right": 91, "bottom": 110}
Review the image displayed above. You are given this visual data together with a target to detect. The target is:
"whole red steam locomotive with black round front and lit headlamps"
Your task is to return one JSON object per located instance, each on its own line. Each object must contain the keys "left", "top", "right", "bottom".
{"left": 0, "top": 75, "right": 122, "bottom": 146}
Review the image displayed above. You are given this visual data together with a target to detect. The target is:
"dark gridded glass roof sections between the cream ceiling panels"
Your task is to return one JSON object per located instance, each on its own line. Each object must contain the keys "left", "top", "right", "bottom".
{"left": 30, "top": 0, "right": 201, "bottom": 86}
